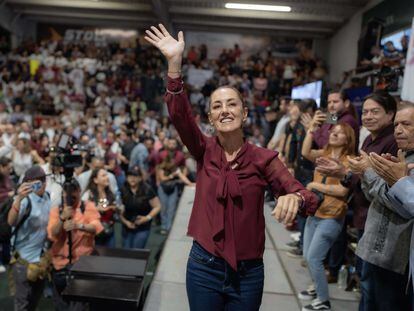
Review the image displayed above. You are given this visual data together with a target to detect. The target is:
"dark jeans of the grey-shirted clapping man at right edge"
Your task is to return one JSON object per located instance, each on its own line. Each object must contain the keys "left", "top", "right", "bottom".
{"left": 359, "top": 261, "right": 413, "bottom": 311}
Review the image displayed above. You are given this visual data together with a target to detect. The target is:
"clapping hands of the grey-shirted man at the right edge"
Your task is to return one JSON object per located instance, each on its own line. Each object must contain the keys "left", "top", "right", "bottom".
{"left": 369, "top": 149, "right": 414, "bottom": 186}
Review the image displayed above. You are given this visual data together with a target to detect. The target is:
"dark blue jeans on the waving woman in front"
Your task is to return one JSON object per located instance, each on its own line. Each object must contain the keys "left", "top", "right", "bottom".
{"left": 186, "top": 241, "right": 264, "bottom": 311}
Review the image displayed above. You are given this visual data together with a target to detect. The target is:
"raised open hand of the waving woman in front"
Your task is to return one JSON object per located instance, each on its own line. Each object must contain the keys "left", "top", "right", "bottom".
{"left": 144, "top": 24, "right": 185, "bottom": 66}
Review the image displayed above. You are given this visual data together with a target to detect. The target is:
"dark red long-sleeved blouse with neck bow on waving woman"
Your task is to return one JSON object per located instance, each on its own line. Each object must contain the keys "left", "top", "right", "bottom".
{"left": 165, "top": 79, "right": 318, "bottom": 270}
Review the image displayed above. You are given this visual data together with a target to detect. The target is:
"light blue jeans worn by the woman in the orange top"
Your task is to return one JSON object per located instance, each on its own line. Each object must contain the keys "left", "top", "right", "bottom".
{"left": 303, "top": 217, "right": 344, "bottom": 301}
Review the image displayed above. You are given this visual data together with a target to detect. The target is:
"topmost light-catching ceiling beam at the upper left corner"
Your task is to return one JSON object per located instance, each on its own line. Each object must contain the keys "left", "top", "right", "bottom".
{"left": 7, "top": 0, "right": 151, "bottom": 12}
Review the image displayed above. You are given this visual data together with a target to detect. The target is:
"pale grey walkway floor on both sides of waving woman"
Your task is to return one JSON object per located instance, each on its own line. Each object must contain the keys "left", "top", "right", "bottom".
{"left": 144, "top": 188, "right": 359, "bottom": 311}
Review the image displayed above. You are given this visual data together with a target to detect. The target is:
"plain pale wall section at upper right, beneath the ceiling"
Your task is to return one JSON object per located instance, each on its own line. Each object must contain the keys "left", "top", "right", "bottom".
{"left": 328, "top": 0, "right": 383, "bottom": 84}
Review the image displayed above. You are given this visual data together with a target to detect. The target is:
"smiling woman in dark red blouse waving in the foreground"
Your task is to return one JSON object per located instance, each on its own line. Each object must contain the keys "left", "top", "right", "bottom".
{"left": 145, "top": 24, "right": 317, "bottom": 311}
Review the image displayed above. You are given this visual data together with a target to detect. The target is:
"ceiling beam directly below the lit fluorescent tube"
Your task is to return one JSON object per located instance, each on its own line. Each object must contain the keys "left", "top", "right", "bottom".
{"left": 170, "top": 5, "right": 344, "bottom": 24}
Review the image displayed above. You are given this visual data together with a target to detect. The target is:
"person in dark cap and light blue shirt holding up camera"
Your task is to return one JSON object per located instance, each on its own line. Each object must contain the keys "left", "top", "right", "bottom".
{"left": 8, "top": 166, "right": 51, "bottom": 310}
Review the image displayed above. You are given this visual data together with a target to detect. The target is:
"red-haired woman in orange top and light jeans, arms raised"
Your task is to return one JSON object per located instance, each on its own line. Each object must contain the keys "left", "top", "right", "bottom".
{"left": 299, "top": 123, "right": 355, "bottom": 310}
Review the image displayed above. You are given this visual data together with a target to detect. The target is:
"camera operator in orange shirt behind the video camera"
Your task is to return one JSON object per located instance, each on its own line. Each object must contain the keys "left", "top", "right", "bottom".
{"left": 47, "top": 180, "right": 103, "bottom": 310}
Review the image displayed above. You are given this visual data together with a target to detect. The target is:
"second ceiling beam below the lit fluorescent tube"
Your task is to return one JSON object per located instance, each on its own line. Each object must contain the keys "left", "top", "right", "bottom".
{"left": 173, "top": 18, "right": 334, "bottom": 34}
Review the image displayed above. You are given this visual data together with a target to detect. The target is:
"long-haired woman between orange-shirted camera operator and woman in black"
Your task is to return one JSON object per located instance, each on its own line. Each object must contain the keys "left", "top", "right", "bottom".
{"left": 82, "top": 168, "right": 118, "bottom": 247}
